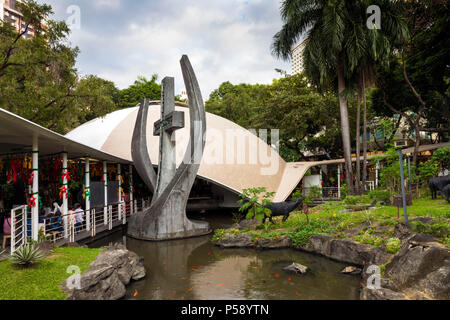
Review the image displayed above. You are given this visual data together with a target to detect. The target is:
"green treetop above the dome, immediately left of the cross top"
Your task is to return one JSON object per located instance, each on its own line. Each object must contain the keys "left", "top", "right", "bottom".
{"left": 118, "top": 74, "right": 161, "bottom": 108}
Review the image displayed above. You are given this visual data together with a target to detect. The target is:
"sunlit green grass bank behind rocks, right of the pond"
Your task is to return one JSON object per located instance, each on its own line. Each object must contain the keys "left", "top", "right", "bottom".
{"left": 213, "top": 198, "right": 450, "bottom": 253}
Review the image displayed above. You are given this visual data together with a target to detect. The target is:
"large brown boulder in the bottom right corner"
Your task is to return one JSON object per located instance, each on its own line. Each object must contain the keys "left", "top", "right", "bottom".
{"left": 386, "top": 237, "right": 450, "bottom": 299}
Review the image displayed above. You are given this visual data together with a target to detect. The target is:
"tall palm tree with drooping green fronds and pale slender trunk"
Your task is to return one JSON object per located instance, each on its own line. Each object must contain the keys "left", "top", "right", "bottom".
{"left": 272, "top": 0, "right": 406, "bottom": 191}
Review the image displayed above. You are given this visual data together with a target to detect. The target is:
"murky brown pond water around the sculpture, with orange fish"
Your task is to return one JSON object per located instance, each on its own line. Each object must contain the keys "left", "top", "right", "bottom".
{"left": 90, "top": 213, "right": 360, "bottom": 300}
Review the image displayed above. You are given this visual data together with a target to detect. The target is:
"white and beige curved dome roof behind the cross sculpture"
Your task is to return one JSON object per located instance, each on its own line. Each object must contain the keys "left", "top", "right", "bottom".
{"left": 66, "top": 104, "right": 309, "bottom": 201}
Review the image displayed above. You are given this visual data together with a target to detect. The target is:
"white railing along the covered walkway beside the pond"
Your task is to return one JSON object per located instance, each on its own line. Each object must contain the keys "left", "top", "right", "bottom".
{"left": 11, "top": 199, "right": 150, "bottom": 254}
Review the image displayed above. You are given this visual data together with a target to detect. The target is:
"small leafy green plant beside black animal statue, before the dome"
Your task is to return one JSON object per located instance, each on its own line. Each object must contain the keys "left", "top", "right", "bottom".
{"left": 238, "top": 188, "right": 275, "bottom": 221}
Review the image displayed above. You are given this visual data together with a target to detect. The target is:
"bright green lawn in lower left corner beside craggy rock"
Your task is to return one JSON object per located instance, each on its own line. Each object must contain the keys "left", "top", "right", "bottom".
{"left": 0, "top": 248, "right": 100, "bottom": 300}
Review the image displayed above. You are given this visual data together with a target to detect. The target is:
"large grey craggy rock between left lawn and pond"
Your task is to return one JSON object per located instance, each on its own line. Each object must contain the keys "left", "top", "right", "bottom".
{"left": 61, "top": 245, "right": 146, "bottom": 300}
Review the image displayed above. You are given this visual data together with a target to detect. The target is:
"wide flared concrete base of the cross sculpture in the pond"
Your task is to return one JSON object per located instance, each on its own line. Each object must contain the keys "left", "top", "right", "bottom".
{"left": 127, "top": 211, "right": 212, "bottom": 241}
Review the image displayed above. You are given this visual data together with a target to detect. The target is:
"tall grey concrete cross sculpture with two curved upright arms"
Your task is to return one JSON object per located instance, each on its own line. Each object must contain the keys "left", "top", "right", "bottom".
{"left": 128, "top": 56, "right": 211, "bottom": 241}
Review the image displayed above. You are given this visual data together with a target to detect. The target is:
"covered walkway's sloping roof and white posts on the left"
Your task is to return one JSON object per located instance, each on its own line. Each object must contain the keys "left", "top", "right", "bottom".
{"left": 0, "top": 108, "right": 133, "bottom": 240}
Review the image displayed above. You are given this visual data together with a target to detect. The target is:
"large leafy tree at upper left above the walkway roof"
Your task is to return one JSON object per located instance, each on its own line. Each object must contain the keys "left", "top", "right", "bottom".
{"left": 0, "top": 0, "right": 117, "bottom": 134}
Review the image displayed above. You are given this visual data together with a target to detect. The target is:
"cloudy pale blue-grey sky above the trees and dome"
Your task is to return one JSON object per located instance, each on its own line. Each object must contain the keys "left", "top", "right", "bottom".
{"left": 38, "top": 0, "right": 291, "bottom": 100}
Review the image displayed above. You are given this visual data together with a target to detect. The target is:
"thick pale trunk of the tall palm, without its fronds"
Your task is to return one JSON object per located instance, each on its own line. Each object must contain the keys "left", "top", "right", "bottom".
{"left": 337, "top": 61, "right": 355, "bottom": 194}
